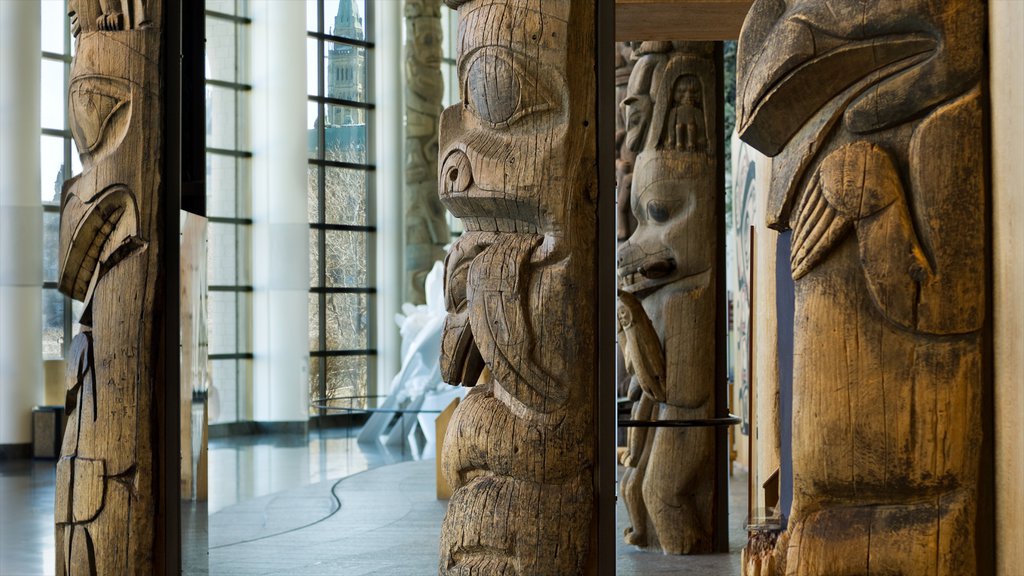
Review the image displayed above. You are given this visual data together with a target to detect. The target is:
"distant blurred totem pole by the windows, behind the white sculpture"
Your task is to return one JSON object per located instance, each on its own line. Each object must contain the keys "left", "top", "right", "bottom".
{"left": 406, "top": 0, "right": 449, "bottom": 304}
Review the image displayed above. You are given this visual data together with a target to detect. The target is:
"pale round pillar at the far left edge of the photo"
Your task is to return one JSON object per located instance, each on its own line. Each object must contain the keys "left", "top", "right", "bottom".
{"left": 0, "top": 0, "right": 43, "bottom": 453}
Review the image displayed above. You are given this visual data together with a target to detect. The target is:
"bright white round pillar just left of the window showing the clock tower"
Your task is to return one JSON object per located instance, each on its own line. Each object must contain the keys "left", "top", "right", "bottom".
{"left": 250, "top": 0, "right": 309, "bottom": 423}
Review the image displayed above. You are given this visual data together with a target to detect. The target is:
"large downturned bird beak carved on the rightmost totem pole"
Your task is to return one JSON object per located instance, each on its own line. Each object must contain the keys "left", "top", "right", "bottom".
{"left": 737, "top": 17, "right": 937, "bottom": 156}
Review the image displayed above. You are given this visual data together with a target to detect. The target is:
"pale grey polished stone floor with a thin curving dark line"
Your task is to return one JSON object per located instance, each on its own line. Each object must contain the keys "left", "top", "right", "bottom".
{"left": 0, "top": 428, "right": 746, "bottom": 576}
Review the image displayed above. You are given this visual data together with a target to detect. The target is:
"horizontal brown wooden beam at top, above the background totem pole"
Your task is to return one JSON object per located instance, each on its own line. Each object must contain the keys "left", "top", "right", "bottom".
{"left": 615, "top": 0, "right": 754, "bottom": 42}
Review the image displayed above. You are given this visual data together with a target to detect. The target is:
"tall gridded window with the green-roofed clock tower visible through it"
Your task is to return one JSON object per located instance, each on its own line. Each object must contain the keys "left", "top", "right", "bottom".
{"left": 306, "top": 0, "right": 376, "bottom": 412}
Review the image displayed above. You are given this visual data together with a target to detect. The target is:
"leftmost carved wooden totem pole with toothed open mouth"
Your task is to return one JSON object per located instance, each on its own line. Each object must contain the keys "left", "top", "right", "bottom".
{"left": 54, "top": 0, "right": 163, "bottom": 575}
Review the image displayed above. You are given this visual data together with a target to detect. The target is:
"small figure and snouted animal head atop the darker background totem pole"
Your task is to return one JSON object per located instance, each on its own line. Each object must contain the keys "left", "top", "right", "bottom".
{"left": 618, "top": 43, "right": 717, "bottom": 315}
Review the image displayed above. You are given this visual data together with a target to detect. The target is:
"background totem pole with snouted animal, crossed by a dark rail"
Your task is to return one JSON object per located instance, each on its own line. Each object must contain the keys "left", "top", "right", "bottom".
{"left": 618, "top": 42, "right": 720, "bottom": 553}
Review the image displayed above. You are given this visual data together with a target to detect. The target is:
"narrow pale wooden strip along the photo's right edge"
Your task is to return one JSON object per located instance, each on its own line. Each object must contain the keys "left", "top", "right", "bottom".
{"left": 988, "top": 0, "right": 1024, "bottom": 576}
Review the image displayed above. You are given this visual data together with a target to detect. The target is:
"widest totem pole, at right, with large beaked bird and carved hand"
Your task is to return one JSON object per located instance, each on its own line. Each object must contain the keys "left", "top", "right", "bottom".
{"left": 737, "top": 0, "right": 989, "bottom": 576}
